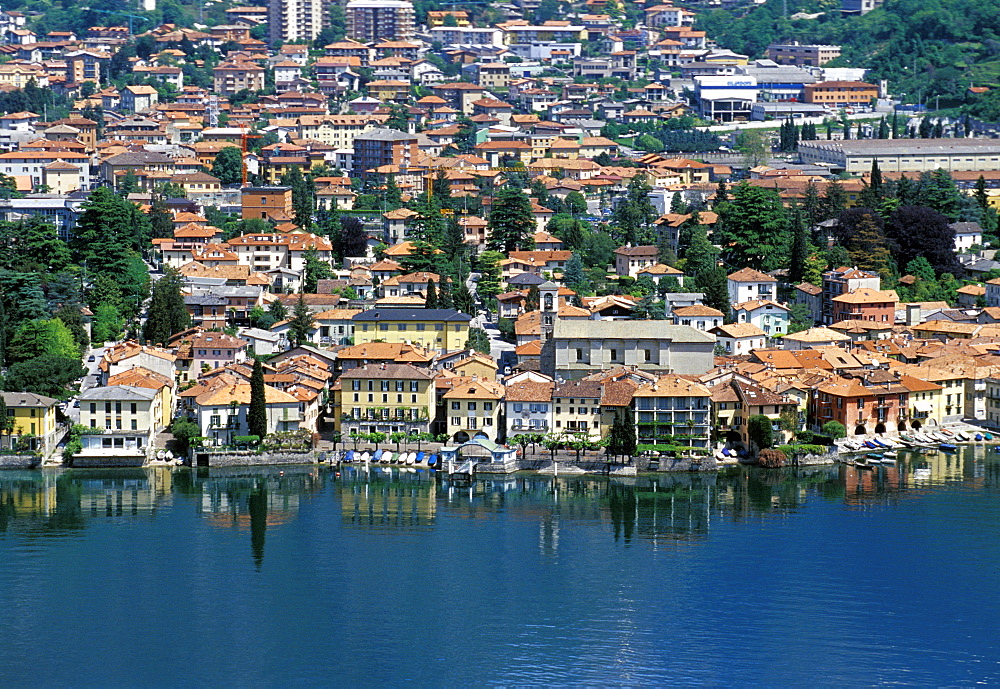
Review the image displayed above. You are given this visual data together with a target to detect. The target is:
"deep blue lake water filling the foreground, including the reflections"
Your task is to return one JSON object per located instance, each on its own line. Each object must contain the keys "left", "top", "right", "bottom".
{"left": 0, "top": 448, "right": 1000, "bottom": 687}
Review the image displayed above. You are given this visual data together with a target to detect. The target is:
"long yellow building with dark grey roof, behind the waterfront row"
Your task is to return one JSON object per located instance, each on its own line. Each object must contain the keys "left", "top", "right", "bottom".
{"left": 351, "top": 308, "right": 472, "bottom": 351}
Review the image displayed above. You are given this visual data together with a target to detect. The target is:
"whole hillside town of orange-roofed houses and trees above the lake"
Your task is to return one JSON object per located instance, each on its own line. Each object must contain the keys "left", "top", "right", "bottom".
{"left": 0, "top": 0, "right": 1000, "bottom": 472}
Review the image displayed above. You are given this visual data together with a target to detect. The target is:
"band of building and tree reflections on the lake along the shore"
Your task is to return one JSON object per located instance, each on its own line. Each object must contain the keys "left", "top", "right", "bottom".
{"left": 0, "top": 446, "right": 1000, "bottom": 548}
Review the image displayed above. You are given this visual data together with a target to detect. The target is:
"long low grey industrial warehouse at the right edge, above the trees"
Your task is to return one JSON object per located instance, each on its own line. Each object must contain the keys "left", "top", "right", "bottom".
{"left": 799, "top": 139, "right": 1000, "bottom": 177}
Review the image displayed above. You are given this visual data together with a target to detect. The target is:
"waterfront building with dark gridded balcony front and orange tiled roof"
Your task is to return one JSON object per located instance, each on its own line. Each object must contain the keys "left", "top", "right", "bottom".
{"left": 632, "top": 375, "right": 712, "bottom": 450}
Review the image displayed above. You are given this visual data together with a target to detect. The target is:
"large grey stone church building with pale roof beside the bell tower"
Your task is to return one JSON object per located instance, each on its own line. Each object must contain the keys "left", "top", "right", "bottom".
{"left": 540, "top": 319, "right": 715, "bottom": 379}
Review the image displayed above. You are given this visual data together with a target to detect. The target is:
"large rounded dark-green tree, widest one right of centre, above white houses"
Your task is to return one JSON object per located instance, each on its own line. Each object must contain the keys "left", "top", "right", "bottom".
{"left": 715, "top": 182, "right": 789, "bottom": 271}
